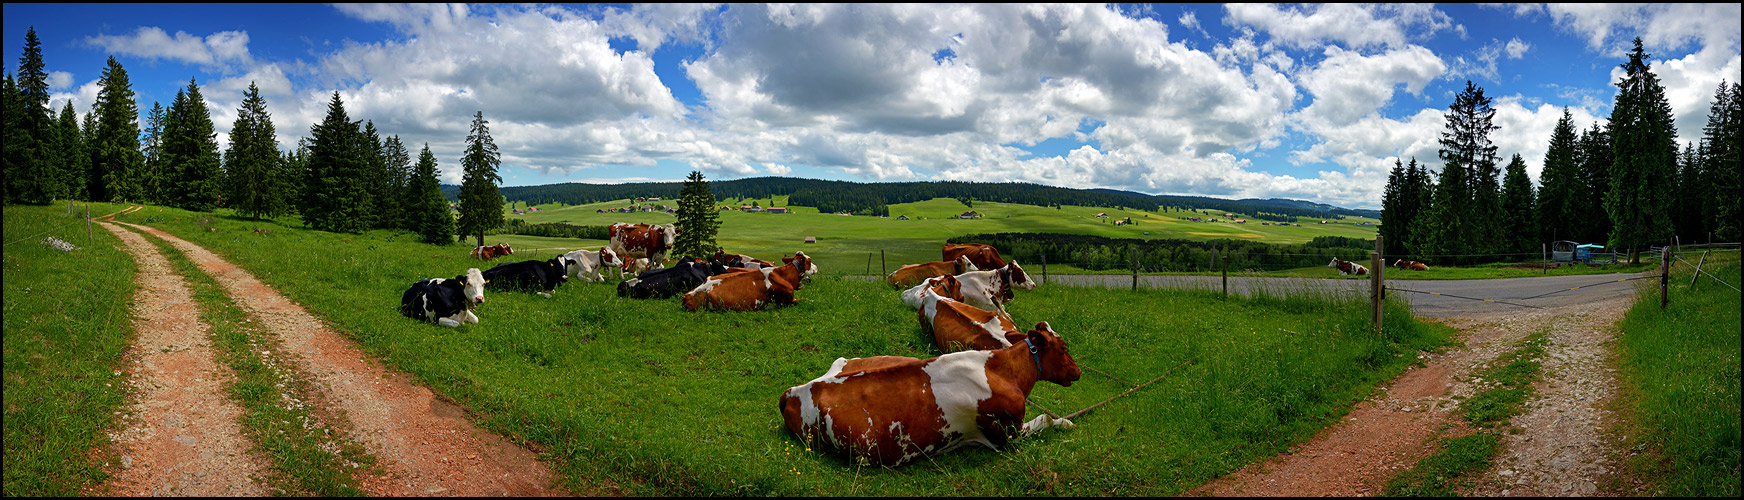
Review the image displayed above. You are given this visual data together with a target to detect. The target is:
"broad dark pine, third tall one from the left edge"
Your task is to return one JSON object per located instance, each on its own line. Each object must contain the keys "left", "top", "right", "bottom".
{"left": 159, "top": 78, "right": 223, "bottom": 213}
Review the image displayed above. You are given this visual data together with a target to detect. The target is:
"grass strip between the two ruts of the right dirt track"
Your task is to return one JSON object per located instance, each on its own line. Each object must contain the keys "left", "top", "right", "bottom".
{"left": 1381, "top": 331, "right": 1549, "bottom": 497}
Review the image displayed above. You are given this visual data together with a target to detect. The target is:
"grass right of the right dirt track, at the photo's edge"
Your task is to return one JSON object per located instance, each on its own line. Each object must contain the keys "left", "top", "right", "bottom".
{"left": 1617, "top": 251, "right": 1741, "bottom": 497}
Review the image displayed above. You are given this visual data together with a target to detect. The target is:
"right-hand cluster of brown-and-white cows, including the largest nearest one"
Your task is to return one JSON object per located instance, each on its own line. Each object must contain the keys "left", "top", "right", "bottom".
{"left": 778, "top": 244, "right": 1080, "bottom": 467}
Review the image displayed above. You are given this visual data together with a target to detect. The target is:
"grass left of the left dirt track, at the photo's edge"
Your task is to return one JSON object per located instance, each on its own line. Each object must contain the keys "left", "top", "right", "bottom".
{"left": 3, "top": 206, "right": 138, "bottom": 497}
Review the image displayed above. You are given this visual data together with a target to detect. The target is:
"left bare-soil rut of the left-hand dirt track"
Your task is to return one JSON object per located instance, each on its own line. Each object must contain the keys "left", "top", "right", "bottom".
{"left": 92, "top": 223, "right": 267, "bottom": 497}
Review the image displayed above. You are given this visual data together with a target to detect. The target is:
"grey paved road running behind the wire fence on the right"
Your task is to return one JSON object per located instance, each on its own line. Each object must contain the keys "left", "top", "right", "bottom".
{"left": 865, "top": 274, "right": 1657, "bottom": 317}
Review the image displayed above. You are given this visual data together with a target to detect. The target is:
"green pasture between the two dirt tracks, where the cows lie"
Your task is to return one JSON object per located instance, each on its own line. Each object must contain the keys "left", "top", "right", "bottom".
{"left": 102, "top": 204, "right": 1448, "bottom": 497}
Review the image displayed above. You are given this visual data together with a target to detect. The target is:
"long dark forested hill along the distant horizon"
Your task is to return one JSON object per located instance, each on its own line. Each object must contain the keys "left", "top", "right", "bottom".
{"left": 443, "top": 178, "right": 1378, "bottom": 218}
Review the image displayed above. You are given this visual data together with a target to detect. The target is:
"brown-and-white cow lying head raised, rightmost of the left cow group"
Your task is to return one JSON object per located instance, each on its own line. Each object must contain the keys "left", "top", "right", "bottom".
{"left": 684, "top": 253, "right": 816, "bottom": 310}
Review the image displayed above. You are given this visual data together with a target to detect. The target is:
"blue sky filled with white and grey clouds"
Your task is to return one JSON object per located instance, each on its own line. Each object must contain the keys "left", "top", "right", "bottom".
{"left": 0, "top": 3, "right": 1741, "bottom": 209}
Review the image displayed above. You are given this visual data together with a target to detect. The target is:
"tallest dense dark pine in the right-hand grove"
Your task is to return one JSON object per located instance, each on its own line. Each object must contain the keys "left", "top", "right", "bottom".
{"left": 1604, "top": 37, "right": 1678, "bottom": 263}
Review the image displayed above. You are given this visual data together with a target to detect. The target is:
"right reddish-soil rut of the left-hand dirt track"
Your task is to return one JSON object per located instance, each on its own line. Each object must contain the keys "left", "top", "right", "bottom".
{"left": 122, "top": 226, "right": 569, "bottom": 497}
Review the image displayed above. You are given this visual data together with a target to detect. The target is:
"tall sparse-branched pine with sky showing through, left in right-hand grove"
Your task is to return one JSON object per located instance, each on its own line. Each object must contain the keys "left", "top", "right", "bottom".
{"left": 1439, "top": 80, "right": 1502, "bottom": 253}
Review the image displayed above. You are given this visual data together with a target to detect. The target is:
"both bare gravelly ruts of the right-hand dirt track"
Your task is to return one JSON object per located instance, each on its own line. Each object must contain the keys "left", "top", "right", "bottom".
{"left": 1184, "top": 296, "right": 1632, "bottom": 497}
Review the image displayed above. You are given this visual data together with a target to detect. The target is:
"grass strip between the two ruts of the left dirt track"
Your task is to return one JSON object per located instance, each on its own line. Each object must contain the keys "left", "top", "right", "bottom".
{"left": 132, "top": 224, "right": 375, "bottom": 497}
